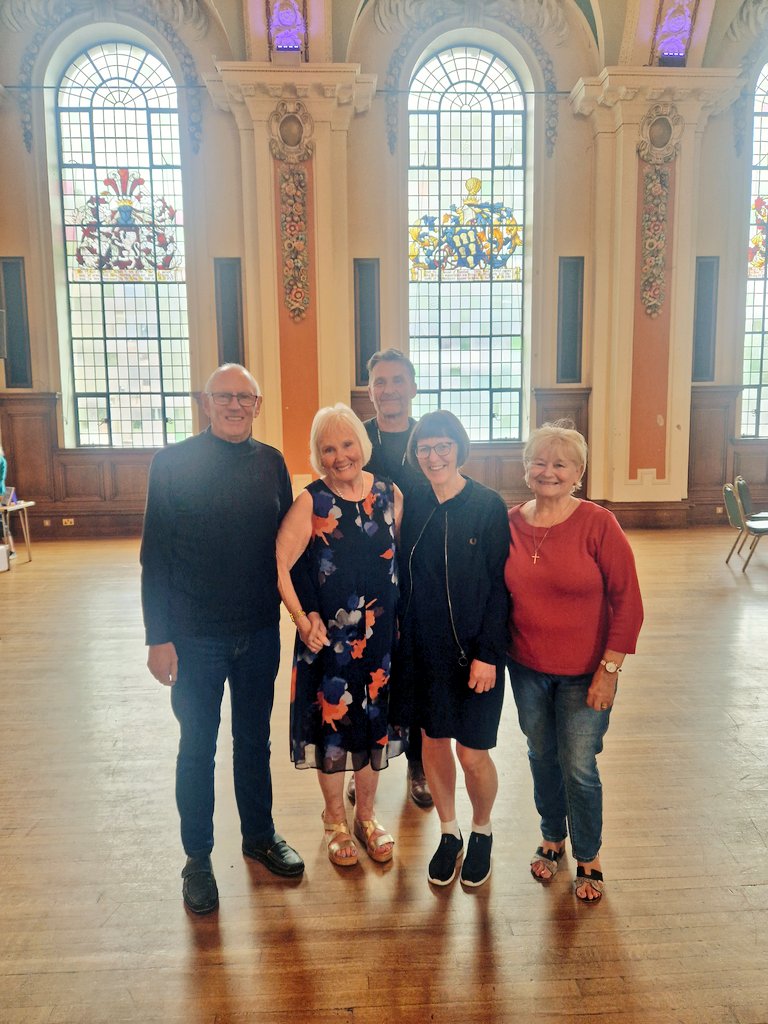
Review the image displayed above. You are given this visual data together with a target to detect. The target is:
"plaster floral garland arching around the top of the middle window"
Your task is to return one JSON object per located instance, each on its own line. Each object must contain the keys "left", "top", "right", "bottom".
{"left": 376, "top": 0, "right": 558, "bottom": 157}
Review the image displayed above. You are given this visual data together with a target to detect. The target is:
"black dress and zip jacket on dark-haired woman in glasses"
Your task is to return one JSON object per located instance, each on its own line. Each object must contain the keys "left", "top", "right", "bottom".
{"left": 396, "top": 479, "right": 509, "bottom": 750}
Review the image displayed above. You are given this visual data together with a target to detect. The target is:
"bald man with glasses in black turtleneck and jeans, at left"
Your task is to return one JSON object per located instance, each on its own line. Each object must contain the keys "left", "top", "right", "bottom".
{"left": 141, "top": 364, "right": 304, "bottom": 913}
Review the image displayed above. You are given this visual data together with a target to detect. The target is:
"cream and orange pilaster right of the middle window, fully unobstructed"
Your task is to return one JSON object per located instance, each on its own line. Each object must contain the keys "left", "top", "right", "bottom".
{"left": 570, "top": 68, "right": 741, "bottom": 502}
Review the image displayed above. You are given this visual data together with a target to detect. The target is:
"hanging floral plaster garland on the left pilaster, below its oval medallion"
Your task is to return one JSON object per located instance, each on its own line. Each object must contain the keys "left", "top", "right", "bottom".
{"left": 280, "top": 164, "right": 309, "bottom": 324}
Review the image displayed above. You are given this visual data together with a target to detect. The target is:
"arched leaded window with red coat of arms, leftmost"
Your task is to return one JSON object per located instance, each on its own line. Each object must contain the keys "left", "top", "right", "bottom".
{"left": 56, "top": 43, "right": 191, "bottom": 447}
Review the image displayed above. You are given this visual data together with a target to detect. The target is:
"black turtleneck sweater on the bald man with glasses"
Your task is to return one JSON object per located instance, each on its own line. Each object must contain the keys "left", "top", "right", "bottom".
{"left": 141, "top": 428, "right": 293, "bottom": 644}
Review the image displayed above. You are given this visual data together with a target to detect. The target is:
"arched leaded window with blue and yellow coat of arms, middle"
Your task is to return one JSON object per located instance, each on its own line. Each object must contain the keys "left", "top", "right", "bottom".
{"left": 409, "top": 46, "right": 525, "bottom": 440}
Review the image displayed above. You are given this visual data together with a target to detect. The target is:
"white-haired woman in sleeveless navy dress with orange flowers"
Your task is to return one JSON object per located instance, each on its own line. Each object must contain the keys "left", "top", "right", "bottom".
{"left": 278, "top": 404, "right": 406, "bottom": 866}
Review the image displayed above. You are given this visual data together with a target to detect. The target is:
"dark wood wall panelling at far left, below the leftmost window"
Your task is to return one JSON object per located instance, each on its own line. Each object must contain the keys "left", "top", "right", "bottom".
{"left": 0, "top": 392, "right": 156, "bottom": 540}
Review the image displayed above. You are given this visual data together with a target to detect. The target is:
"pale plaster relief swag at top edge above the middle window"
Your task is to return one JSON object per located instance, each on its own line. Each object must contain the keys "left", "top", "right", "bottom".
{"left": 374, "top": 0, "right": 568, "bottom": 43}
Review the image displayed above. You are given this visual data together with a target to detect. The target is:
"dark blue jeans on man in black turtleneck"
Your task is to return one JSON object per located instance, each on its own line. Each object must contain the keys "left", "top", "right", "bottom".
{"left": 171, "top": 626, "right": 280, "bottom": 857}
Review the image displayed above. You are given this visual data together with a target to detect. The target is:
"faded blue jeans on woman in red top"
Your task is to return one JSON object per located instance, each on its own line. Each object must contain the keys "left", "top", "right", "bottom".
{"left": 507, "top": 658, "right": 610, "bottom": 863}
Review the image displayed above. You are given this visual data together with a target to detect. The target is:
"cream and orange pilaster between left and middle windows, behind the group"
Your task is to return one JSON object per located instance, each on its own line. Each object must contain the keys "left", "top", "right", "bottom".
{"left": 206, "top": 62, "right": 376, "bottom": 476}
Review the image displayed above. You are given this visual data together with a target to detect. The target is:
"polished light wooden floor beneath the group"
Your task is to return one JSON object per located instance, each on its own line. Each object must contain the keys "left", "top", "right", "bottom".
{"left": 0, "top": 528, "right": 768, "bottom": 1024}
